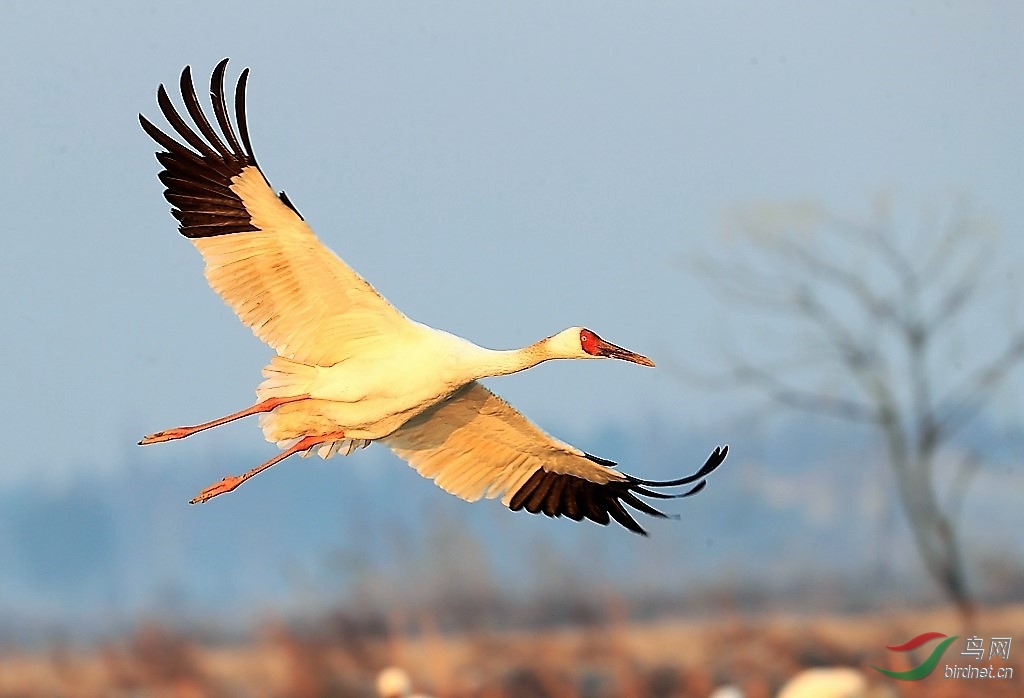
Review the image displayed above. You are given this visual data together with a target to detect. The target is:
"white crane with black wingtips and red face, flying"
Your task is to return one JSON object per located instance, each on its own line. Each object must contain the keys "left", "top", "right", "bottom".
{"left": 139, "top": 58, "right": 728, "bottom": 533}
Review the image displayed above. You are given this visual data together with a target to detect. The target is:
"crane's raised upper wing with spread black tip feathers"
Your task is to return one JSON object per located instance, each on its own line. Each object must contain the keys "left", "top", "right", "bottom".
{"left": 139, "top": 58, "right": 412, "bottom": 365}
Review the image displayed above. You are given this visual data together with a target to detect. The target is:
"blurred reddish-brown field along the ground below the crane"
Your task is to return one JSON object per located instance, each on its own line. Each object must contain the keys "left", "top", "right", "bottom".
{"left": 0, "top": 605, "right": 1024, "bottom": 698}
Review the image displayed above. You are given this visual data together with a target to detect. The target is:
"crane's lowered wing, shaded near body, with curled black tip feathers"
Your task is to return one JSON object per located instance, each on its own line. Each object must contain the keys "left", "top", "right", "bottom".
{"left": 381, "top": 382, "right": 729, "bottom": 535}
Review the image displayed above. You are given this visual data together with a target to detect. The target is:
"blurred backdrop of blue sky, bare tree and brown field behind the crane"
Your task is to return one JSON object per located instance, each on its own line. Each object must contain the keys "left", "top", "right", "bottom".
{"left": 0, "top": 0, "right": 1024, "bottom": 697}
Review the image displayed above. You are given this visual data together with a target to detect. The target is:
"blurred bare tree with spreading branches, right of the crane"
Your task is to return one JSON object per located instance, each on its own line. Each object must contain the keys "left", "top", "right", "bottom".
{"left": 700, "top": 195, "right": 1024, "bottom": 615}
